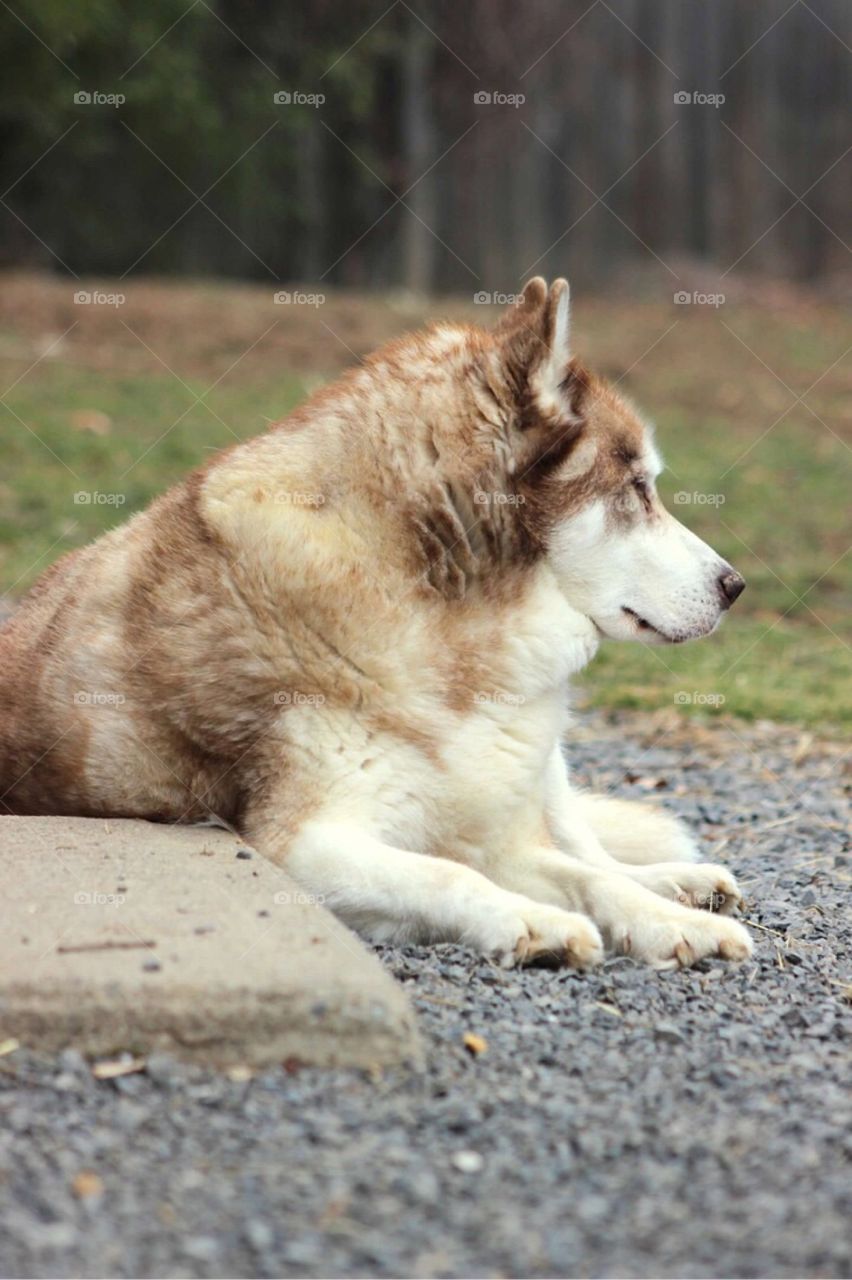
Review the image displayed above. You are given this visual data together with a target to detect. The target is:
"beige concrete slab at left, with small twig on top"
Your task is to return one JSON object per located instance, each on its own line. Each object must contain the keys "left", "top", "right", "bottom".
{"left": 0, "top": 817, "right": 420, "bottom": 1066}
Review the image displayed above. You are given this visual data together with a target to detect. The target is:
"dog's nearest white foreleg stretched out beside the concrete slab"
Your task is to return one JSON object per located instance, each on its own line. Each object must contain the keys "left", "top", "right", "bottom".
{"left": 247, "top": 820, "right": 603, "bottom": 969}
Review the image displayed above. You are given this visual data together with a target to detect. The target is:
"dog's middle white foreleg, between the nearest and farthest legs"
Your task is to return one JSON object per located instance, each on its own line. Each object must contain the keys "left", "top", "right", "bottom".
{"left": 495, "top": 849, "right": 751, "bottom": 969}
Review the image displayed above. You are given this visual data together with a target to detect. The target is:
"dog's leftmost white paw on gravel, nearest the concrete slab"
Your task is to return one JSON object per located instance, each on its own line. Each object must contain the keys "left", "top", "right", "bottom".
{"left": 484, "top": 901, "right": 604, "bottom": 969}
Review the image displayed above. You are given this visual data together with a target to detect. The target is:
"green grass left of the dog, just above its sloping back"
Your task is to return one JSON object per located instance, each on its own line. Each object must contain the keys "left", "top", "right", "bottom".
{"left": 0, "top": 365, "right": 306, "bottom": 595}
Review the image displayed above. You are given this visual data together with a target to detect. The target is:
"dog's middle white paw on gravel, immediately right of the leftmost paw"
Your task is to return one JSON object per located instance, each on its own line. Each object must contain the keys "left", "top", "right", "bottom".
{"left": 614, "top": 904, "right": 752, "bottom": 969}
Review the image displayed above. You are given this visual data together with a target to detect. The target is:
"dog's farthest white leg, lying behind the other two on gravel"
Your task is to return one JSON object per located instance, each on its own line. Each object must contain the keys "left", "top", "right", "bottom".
{"left": 546, "top": 748, "right": 742, "bottom": 914}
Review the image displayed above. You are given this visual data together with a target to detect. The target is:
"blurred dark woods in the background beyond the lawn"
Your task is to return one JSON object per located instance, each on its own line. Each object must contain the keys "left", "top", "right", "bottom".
{"left": 0, "top": 0, "right": 852, "bottom": 291}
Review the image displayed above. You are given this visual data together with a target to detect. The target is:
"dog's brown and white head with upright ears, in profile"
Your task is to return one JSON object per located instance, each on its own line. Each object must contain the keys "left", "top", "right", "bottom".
{"left": 480, "top": 278, "right": 745, "bottom": 644}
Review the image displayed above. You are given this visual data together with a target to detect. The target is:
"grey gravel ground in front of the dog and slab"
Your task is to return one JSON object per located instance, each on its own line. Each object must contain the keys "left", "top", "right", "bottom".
{"left": 0, "top": 714, "right": 852, "bottom": 1277}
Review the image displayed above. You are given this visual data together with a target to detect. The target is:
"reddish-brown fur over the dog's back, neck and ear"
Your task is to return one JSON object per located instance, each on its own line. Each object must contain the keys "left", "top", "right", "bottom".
{"left": 0, "top": 282, "right": 649, "bottom": 822}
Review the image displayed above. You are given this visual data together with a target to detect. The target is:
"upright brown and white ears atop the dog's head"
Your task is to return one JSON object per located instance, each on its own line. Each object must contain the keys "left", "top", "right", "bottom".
{"left": 498, "top": 275, "right": 571, "bottom": 412}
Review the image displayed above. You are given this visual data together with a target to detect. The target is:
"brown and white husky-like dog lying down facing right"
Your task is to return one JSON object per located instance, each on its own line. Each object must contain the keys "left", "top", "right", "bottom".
{"left": 0, "top": 278, "right": 751, "bottom": 969}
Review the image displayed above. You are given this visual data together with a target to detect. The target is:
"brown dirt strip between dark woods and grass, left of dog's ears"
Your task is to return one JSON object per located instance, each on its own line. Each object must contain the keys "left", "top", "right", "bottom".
{"left": 0, "top": 274, "right": 470, "bottom": 380}
